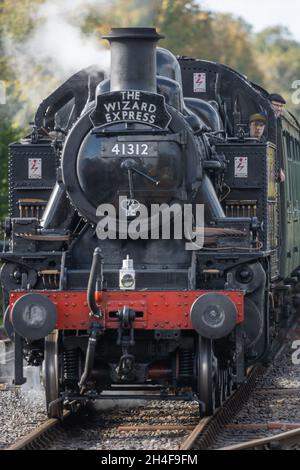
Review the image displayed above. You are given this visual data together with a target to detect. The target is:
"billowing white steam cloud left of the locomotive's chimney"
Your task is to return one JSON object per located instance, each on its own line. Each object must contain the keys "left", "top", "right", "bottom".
{"left": 5, "top": 0, "right": 110, "bottom": 125}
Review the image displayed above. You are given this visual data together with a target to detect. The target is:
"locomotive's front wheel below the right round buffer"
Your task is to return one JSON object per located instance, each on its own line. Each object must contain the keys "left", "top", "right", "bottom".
{"left": 196, "top": 336, "right": 219, "bottom": 416}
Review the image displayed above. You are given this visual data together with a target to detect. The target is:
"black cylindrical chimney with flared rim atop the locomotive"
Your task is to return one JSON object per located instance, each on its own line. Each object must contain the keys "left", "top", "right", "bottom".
{"left": 102, "top": 28, "right": 163, "bottom": 93}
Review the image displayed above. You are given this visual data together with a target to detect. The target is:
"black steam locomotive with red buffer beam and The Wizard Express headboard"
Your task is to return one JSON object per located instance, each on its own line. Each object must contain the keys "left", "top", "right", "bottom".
{"left": 1, "top": 28, "right": 300, "bottom": 417}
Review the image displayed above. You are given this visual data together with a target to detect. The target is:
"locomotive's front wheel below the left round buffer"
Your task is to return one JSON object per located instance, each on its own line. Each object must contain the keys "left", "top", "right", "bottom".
{"left": 44, "top": 330, "right": 63, "bottom": 419}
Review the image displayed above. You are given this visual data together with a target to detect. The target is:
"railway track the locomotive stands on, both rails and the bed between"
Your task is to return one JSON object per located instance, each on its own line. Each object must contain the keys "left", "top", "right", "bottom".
{"left": 7, "top": 367, "right": 262, "bottom": 450}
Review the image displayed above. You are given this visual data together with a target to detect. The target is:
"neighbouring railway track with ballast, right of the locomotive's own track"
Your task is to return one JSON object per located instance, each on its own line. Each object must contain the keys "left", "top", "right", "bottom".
{"left": 212, "top": 322, "right": 300, "bottom": 450}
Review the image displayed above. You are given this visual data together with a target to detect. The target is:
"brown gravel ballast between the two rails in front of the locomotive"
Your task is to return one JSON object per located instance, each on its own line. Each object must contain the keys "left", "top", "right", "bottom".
{"left": 48, "top": 401, "right": 199, "bottom": 450}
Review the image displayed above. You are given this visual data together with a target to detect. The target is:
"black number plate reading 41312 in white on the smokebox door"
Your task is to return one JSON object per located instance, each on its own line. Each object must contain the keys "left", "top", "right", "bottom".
{"left": 101, "top": 142, "right": 158, "bottom": 157}
